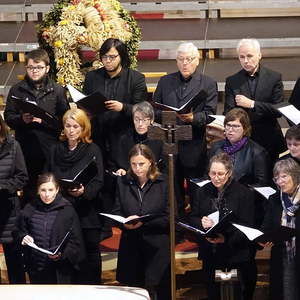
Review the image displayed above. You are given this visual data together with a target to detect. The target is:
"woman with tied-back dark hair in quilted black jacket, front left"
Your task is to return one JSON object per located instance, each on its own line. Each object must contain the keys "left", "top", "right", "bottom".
{"left": 14, "top": 173, "right": 84, "bottom": 284}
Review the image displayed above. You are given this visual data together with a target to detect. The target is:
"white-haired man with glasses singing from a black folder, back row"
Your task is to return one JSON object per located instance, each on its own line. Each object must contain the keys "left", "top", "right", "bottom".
{"left": 154, "top": 43, "right": 218, "bottom": 214}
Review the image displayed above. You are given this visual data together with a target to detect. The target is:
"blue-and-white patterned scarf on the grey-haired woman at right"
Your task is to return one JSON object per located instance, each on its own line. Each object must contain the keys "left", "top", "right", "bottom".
{"left": 280, "top": 185, "right": 300, "bottom": 262}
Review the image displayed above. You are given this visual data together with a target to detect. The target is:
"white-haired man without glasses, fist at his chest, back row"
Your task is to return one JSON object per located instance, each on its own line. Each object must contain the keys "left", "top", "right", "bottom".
{"left": 224, "top": 39, "right": 286, "bottom": 164}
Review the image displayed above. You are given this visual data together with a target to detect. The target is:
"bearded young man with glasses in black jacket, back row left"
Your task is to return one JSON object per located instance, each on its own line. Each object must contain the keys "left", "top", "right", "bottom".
{"left": 4, "top": 49, "right": 69, "bottom": 203}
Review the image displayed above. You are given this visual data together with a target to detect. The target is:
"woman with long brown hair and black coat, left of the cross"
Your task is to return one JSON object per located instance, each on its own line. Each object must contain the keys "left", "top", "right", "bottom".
{"left": 113, "top": 144, "right": 171, "bottom": 300}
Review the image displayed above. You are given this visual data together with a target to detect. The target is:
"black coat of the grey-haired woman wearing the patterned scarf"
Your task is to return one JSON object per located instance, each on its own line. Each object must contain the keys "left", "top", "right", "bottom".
{"left": 261, "top": 191, "right": 300, "bottom": 300}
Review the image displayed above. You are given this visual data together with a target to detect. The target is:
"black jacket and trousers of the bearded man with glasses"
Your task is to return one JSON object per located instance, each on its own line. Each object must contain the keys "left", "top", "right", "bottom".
{"left": 4, "top": 78, "right": 69, "bottom": 166}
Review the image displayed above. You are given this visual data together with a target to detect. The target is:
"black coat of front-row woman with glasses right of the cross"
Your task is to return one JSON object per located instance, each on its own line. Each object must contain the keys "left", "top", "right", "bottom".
{"left": 190, "top": 181, "right": 254, "bottom": 268}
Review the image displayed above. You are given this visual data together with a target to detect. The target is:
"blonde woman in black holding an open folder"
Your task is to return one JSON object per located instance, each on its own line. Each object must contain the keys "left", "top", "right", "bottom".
{"left": 45, "top": 109, "right": 103, "bottom": 284}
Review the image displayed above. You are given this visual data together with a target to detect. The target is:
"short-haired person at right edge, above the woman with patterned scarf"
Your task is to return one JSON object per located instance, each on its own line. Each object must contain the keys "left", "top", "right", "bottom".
{"left": 280, "top": 125, "right": 300, "bottom": 164}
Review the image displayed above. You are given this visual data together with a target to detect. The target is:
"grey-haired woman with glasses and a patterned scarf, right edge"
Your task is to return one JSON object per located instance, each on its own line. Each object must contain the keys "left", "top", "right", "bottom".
{"left": 262, "top": 158, "right": 300, "bottom": 300}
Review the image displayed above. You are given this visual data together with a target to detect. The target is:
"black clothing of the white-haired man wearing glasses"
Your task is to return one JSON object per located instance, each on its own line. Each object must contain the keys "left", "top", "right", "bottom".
{"left": 154, "top": 71, "right": 218, "bottom": 168}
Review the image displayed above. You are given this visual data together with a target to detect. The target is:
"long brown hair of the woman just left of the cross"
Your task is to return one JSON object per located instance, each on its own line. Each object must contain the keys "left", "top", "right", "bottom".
{"left": 128, "top": 144, "right": 160, "bottom": 180}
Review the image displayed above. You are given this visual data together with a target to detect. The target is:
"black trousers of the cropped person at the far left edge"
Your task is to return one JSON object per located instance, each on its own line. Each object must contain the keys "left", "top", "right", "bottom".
{"left": 2, "top": 242, "right": 26, "bottom": 284}
